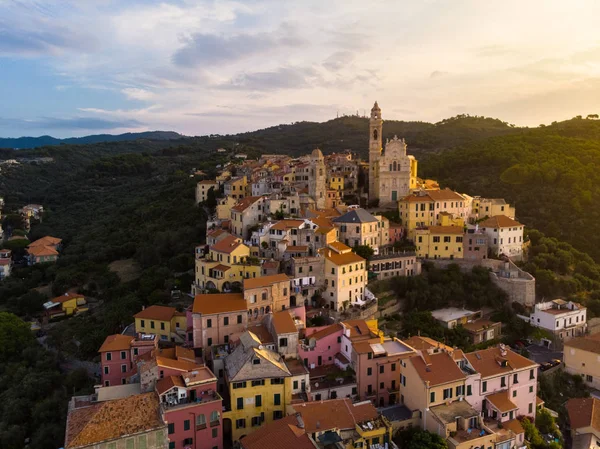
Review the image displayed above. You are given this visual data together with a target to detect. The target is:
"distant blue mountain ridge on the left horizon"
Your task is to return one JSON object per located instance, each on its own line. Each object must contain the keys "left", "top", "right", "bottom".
{"left": 0, "top": 131, "right": 185, "bottom": 150}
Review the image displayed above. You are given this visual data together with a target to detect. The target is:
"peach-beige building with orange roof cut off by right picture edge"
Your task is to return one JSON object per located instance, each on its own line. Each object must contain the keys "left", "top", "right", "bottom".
{"left": 563, "top": 334, "right": 600, "bottom": 389}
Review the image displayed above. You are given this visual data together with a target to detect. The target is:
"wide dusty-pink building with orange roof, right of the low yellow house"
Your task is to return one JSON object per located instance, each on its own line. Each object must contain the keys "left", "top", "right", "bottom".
{"left": 188, "top": 293, "right": 248, "bottom": 352}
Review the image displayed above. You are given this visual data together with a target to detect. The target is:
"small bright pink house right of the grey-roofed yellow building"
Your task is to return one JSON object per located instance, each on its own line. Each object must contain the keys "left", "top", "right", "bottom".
{"left": 298, "top": 323, "right": 343, "bottom": 369}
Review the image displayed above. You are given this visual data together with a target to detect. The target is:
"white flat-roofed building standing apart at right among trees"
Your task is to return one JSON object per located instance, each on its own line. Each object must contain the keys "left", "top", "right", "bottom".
{"left": 522, "top": 299, "right": 587, "bottom": 344}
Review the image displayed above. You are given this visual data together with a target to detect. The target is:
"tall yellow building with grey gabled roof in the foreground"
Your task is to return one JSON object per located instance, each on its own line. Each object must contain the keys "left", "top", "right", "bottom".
{"left": 223, "top": 331, "right": 292, "bottom": 441}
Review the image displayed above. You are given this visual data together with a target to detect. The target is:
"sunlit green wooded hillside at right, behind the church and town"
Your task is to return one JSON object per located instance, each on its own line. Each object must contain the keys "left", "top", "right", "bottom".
{"left": 419, "top": 118, "right": 600, "bottom": 261}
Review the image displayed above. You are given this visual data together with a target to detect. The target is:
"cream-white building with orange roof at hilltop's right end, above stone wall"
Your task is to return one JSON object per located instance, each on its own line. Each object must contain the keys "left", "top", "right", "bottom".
{"left": 479, "top": 215, "right": 524, "bottom": 260}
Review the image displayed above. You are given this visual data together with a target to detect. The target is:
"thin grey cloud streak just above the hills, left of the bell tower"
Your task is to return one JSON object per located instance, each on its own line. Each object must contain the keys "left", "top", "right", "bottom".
{"left": 219, "top": 67, "right": 319, "bottom": 91}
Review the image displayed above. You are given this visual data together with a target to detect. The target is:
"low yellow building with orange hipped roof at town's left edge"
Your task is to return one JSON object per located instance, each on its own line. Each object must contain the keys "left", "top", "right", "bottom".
{"left": 133, "top": 306, "right": 187, "bottom": 343}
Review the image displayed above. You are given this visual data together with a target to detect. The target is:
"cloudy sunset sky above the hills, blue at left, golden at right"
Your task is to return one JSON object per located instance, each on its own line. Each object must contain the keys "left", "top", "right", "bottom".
{"left": 0, "top": 0, "right": 600, "bottom": 137}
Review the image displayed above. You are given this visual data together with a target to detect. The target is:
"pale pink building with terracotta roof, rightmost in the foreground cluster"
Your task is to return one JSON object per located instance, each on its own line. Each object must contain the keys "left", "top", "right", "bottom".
{"left": 465, "top": 346, "right": 539, "bottom": 422}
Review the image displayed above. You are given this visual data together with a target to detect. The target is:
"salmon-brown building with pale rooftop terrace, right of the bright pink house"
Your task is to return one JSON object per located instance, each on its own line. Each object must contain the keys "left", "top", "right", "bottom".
{"left": 352, "top": 337, "right": 415, "bottom": 407}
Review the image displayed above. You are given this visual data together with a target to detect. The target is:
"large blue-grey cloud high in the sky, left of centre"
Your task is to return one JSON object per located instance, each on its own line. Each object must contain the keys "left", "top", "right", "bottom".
{"left": 173, "top": 27, "right": 304, "bottom": 67}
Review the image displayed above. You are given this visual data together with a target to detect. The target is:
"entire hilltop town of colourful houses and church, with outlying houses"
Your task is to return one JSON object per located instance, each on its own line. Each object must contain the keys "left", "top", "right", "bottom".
{"left": 0, "top": 102, "right": 600, "bottom": 449}
